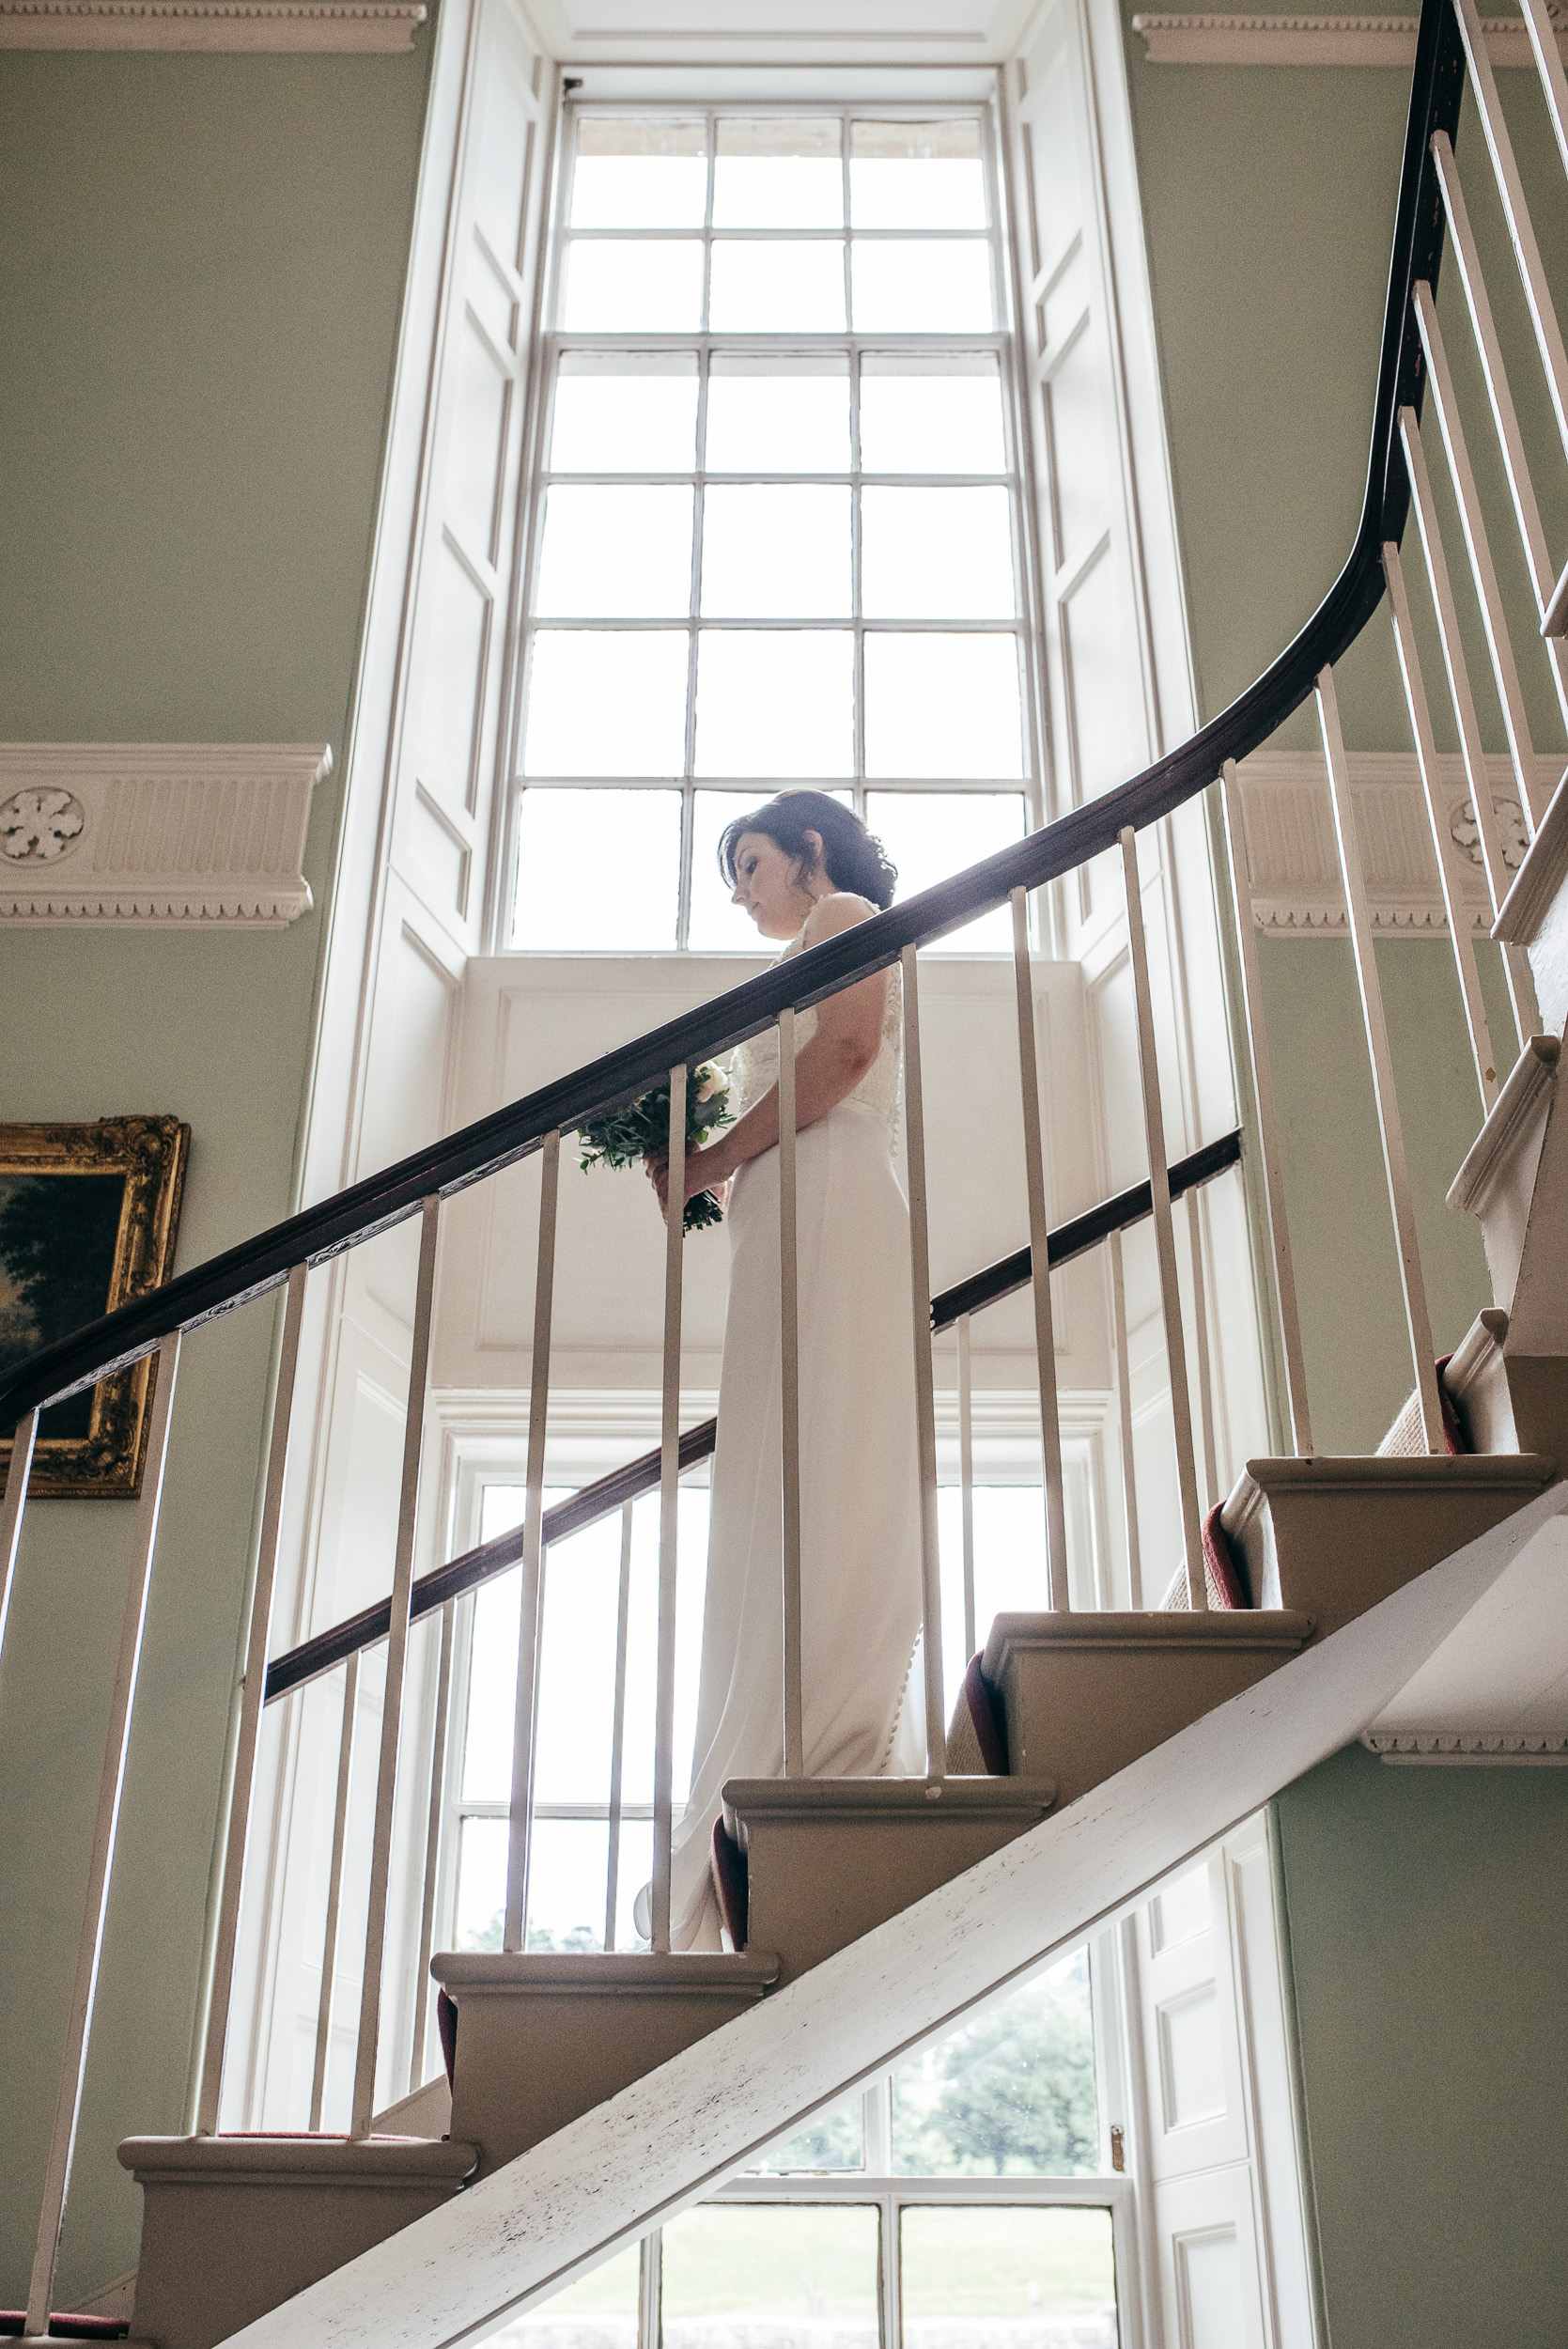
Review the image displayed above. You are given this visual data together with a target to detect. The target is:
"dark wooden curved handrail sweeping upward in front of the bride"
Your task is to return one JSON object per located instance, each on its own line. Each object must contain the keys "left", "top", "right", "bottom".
{"left": 0, "top": 0, "right": 1465, "bottom": 1428}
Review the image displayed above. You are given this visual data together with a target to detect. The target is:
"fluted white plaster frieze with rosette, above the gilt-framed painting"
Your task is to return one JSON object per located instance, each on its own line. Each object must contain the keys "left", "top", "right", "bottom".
{"left": 0, "top": 742, "right": 331, "bottom": 930}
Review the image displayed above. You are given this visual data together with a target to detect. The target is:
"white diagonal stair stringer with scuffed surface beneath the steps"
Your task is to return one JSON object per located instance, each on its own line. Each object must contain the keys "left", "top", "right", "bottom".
{"left": 220, "top": 1483, "right": 1568, "bottom": 2349}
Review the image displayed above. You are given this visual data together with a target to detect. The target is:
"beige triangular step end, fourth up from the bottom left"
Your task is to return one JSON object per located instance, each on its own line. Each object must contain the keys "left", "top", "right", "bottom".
{"left": 1000, "top": 1642, "right": 1298, "bottom": 1809}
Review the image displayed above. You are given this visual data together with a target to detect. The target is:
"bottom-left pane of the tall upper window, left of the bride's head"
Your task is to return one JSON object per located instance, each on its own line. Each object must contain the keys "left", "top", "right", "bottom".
{"left": 512, "top": 789, "right": 681, "bottom": 954}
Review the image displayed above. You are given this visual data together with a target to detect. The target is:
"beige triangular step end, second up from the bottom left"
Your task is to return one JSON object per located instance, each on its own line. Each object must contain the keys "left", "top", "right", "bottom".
{"left": 453, "top": 1990, "right": 758, "bottom": 2178}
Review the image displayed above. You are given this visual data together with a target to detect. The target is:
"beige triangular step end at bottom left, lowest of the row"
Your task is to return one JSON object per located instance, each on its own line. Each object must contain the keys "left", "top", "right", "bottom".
{"left": 132, "top": 2178, "right": 458, "bottom": 2349}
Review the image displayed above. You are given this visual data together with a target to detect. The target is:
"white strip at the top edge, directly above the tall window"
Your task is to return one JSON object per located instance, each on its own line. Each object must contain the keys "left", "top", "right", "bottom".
{"left": 528, "top": 0, "right": 1040, "bottom": 66}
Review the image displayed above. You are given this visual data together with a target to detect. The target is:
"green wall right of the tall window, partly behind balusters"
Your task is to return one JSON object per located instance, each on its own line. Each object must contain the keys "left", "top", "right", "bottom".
{"left": 1125, "top": 9, "right": 1568, "bottom": 1452}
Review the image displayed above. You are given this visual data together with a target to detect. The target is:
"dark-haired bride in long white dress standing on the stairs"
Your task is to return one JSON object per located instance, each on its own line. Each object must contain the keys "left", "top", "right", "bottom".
{"left": 648, "top": 792, "right": 924, "bottom": 1950}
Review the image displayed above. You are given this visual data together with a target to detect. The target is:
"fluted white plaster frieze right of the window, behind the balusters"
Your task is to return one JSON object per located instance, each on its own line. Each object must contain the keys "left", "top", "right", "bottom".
{"left": 1239, "top": 750, "right": 1557, "bottom": 938}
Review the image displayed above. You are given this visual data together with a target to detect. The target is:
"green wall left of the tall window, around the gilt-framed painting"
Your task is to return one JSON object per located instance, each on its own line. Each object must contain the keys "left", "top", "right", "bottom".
{"left": 0, "top": 31, "right": 429, "bottom": 2305}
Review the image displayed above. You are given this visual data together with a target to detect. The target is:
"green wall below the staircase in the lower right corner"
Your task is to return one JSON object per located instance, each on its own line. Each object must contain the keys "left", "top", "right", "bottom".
{"left": 1277, "top": 1746, "right": 1568, "bottom": 2349}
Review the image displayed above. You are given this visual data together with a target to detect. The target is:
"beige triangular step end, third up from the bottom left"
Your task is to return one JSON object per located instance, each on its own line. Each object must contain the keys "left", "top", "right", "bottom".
{"left": 747, "top": 1804, "right": 1045, "bottom": 1983}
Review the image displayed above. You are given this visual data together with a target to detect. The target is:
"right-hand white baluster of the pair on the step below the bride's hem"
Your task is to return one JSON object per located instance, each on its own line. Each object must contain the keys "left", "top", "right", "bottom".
{"left": 349, "top": 1196, "right": 442, "bottom": 2138}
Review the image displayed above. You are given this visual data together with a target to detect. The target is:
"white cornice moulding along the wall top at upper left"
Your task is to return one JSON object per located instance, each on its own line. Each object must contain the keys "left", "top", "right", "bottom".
{"left": 0, "top": 0, "right": 425, "bottom": 54}
